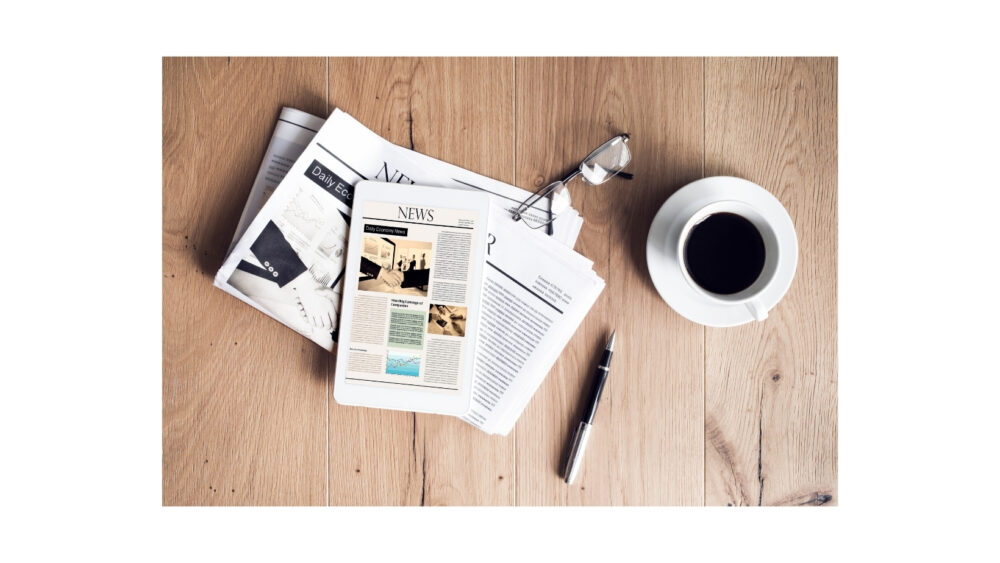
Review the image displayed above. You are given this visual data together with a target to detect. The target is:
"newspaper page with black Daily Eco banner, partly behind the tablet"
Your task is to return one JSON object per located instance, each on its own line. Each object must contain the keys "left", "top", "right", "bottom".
{"left": 215, "top": 109, "right": 582, "bottom": 351}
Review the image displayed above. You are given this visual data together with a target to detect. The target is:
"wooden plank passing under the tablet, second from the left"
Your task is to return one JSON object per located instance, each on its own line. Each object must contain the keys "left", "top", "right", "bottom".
{"left": 330, "top": 58, "right": 514, "bottom": 505}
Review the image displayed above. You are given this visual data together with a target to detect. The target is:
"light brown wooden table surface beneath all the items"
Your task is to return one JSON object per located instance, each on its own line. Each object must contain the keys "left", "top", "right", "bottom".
{"left": 164, "top": 58, "right": 838, "bottom": 505}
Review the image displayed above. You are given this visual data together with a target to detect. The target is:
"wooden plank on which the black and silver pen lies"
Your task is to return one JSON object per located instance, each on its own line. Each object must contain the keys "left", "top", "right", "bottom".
{"left": 516, "top": 58, "right": 704, "bottom": 505}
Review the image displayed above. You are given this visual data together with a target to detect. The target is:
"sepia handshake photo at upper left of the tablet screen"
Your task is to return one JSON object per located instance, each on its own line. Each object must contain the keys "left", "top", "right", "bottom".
{"left": 358, "top": 235, "right": 432, "bottom": 297}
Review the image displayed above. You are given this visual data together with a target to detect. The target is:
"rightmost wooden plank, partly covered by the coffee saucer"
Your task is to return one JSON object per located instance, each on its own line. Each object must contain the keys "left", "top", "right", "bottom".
{"left": 705, "top": 59, "right": 837, "bottom": 505}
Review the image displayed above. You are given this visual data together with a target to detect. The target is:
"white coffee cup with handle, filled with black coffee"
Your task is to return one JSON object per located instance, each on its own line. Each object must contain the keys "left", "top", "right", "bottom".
{"left": 676, "top": 200, "right": 785, "bottom": 321}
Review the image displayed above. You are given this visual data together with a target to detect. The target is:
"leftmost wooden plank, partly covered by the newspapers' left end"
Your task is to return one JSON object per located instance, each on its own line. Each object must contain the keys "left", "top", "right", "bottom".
{"left": 162, "top": 57, "right": 331, "bottom": 505}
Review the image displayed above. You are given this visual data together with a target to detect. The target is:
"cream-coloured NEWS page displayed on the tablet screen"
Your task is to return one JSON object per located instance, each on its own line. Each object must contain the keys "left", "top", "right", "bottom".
{"left": 338, "top": 196, "right": 485, "bottom": 392}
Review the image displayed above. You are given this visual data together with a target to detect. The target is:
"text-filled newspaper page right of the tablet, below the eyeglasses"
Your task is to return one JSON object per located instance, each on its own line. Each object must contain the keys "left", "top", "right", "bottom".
{"left": 463, "top": 209, "right": 604, "bottom": 435}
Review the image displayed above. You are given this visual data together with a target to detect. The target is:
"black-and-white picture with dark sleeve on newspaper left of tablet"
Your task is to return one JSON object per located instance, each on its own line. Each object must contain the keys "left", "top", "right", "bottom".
{"left": 229, "top": 190, "right": 348, "bottom": 349}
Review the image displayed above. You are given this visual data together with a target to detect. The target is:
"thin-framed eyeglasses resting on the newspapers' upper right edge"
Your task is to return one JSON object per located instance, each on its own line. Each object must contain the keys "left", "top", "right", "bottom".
{"left": 513, "top": 133, "right": 632, "bottom": 235}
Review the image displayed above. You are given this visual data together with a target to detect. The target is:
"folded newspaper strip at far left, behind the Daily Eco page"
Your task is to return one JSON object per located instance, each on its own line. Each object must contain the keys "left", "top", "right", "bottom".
{"left": 227, "top": 107, "right": 324, "bottom": 254}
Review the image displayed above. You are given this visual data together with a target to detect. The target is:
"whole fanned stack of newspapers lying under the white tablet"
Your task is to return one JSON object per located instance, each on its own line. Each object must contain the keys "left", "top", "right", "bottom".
{"left": 215, "top": 108, "right": 604, "bottom": 435}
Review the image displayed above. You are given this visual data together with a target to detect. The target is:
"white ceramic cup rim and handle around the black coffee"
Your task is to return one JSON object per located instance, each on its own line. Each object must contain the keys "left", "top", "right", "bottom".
{"left": 677, "top": 200, "right": 781, "bottom": 321}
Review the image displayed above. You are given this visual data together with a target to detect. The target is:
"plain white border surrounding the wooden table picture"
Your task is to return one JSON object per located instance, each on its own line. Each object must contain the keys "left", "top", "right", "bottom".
{"left": 7, "top": 0, "right": 1000, "bottom": 563}
